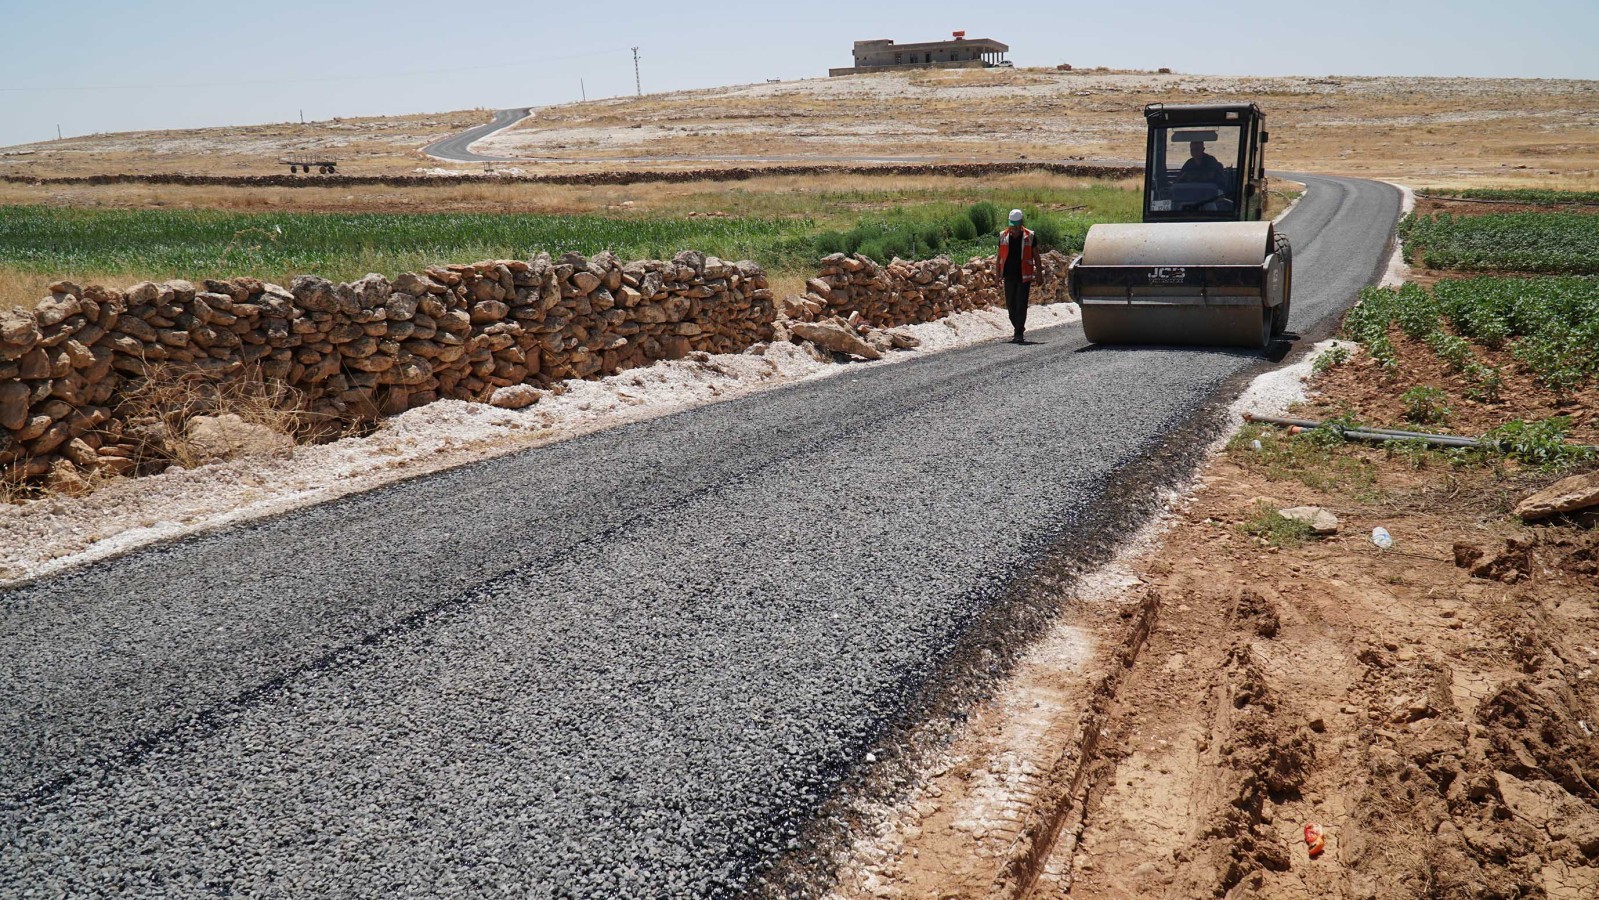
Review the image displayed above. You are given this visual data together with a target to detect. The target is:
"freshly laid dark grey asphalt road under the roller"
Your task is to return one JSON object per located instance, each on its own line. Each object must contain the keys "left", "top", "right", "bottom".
{"left": 0, "top": 177, "right": 1399, "bottom": 897}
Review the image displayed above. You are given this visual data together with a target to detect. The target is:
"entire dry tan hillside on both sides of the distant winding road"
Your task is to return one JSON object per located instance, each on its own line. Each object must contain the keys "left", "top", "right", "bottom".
{"left": 12, "top": 69, "right": 1599, "bottom": 189}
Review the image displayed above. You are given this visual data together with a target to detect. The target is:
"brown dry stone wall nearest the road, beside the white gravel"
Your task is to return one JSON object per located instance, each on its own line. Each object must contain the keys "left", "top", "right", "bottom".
{"left": 0, "top": 251, "right": 1067, "bottom": 483}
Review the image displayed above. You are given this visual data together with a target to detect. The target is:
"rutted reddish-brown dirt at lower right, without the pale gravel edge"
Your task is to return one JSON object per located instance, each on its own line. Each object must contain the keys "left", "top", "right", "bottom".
{"left": 1041, "top": 446, "right": 1599, "bottom": 898}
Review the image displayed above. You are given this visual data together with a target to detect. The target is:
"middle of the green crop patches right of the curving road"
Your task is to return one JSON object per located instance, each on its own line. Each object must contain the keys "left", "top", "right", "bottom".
{"left": 1399, "top": 213, "right": 1599, "bottom": 275}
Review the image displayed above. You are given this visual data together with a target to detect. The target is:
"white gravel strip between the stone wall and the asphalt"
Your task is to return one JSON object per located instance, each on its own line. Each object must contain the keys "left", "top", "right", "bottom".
{"left": 0, "top": 304, "right": 1078, "bottom": 585}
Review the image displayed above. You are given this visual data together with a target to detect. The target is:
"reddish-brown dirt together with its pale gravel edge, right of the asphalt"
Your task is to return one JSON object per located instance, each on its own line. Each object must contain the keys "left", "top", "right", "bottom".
{"left": 835, "top": 353, "right": 1599, "bottom": 898}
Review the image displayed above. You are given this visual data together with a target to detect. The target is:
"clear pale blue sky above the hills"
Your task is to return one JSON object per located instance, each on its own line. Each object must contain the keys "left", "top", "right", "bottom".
{"left": 0, "top": 0, "right": 1599, "bottom": 145}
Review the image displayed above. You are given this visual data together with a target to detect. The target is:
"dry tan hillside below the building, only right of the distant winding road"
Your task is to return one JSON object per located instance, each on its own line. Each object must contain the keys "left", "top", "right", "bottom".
{"left": 478, "top": 69, "right": 1599, "bottom": 185}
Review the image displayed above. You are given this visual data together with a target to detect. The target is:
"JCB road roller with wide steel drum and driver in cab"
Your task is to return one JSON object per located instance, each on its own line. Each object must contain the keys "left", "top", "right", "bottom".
{"left": 1067, "top": 102, "right": 1294, "bottom": 348}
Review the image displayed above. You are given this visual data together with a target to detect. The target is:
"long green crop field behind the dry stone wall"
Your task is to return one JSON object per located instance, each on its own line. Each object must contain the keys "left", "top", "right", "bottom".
{"left": 0, "top": 184, "right": 1138, "bottom": 305}
